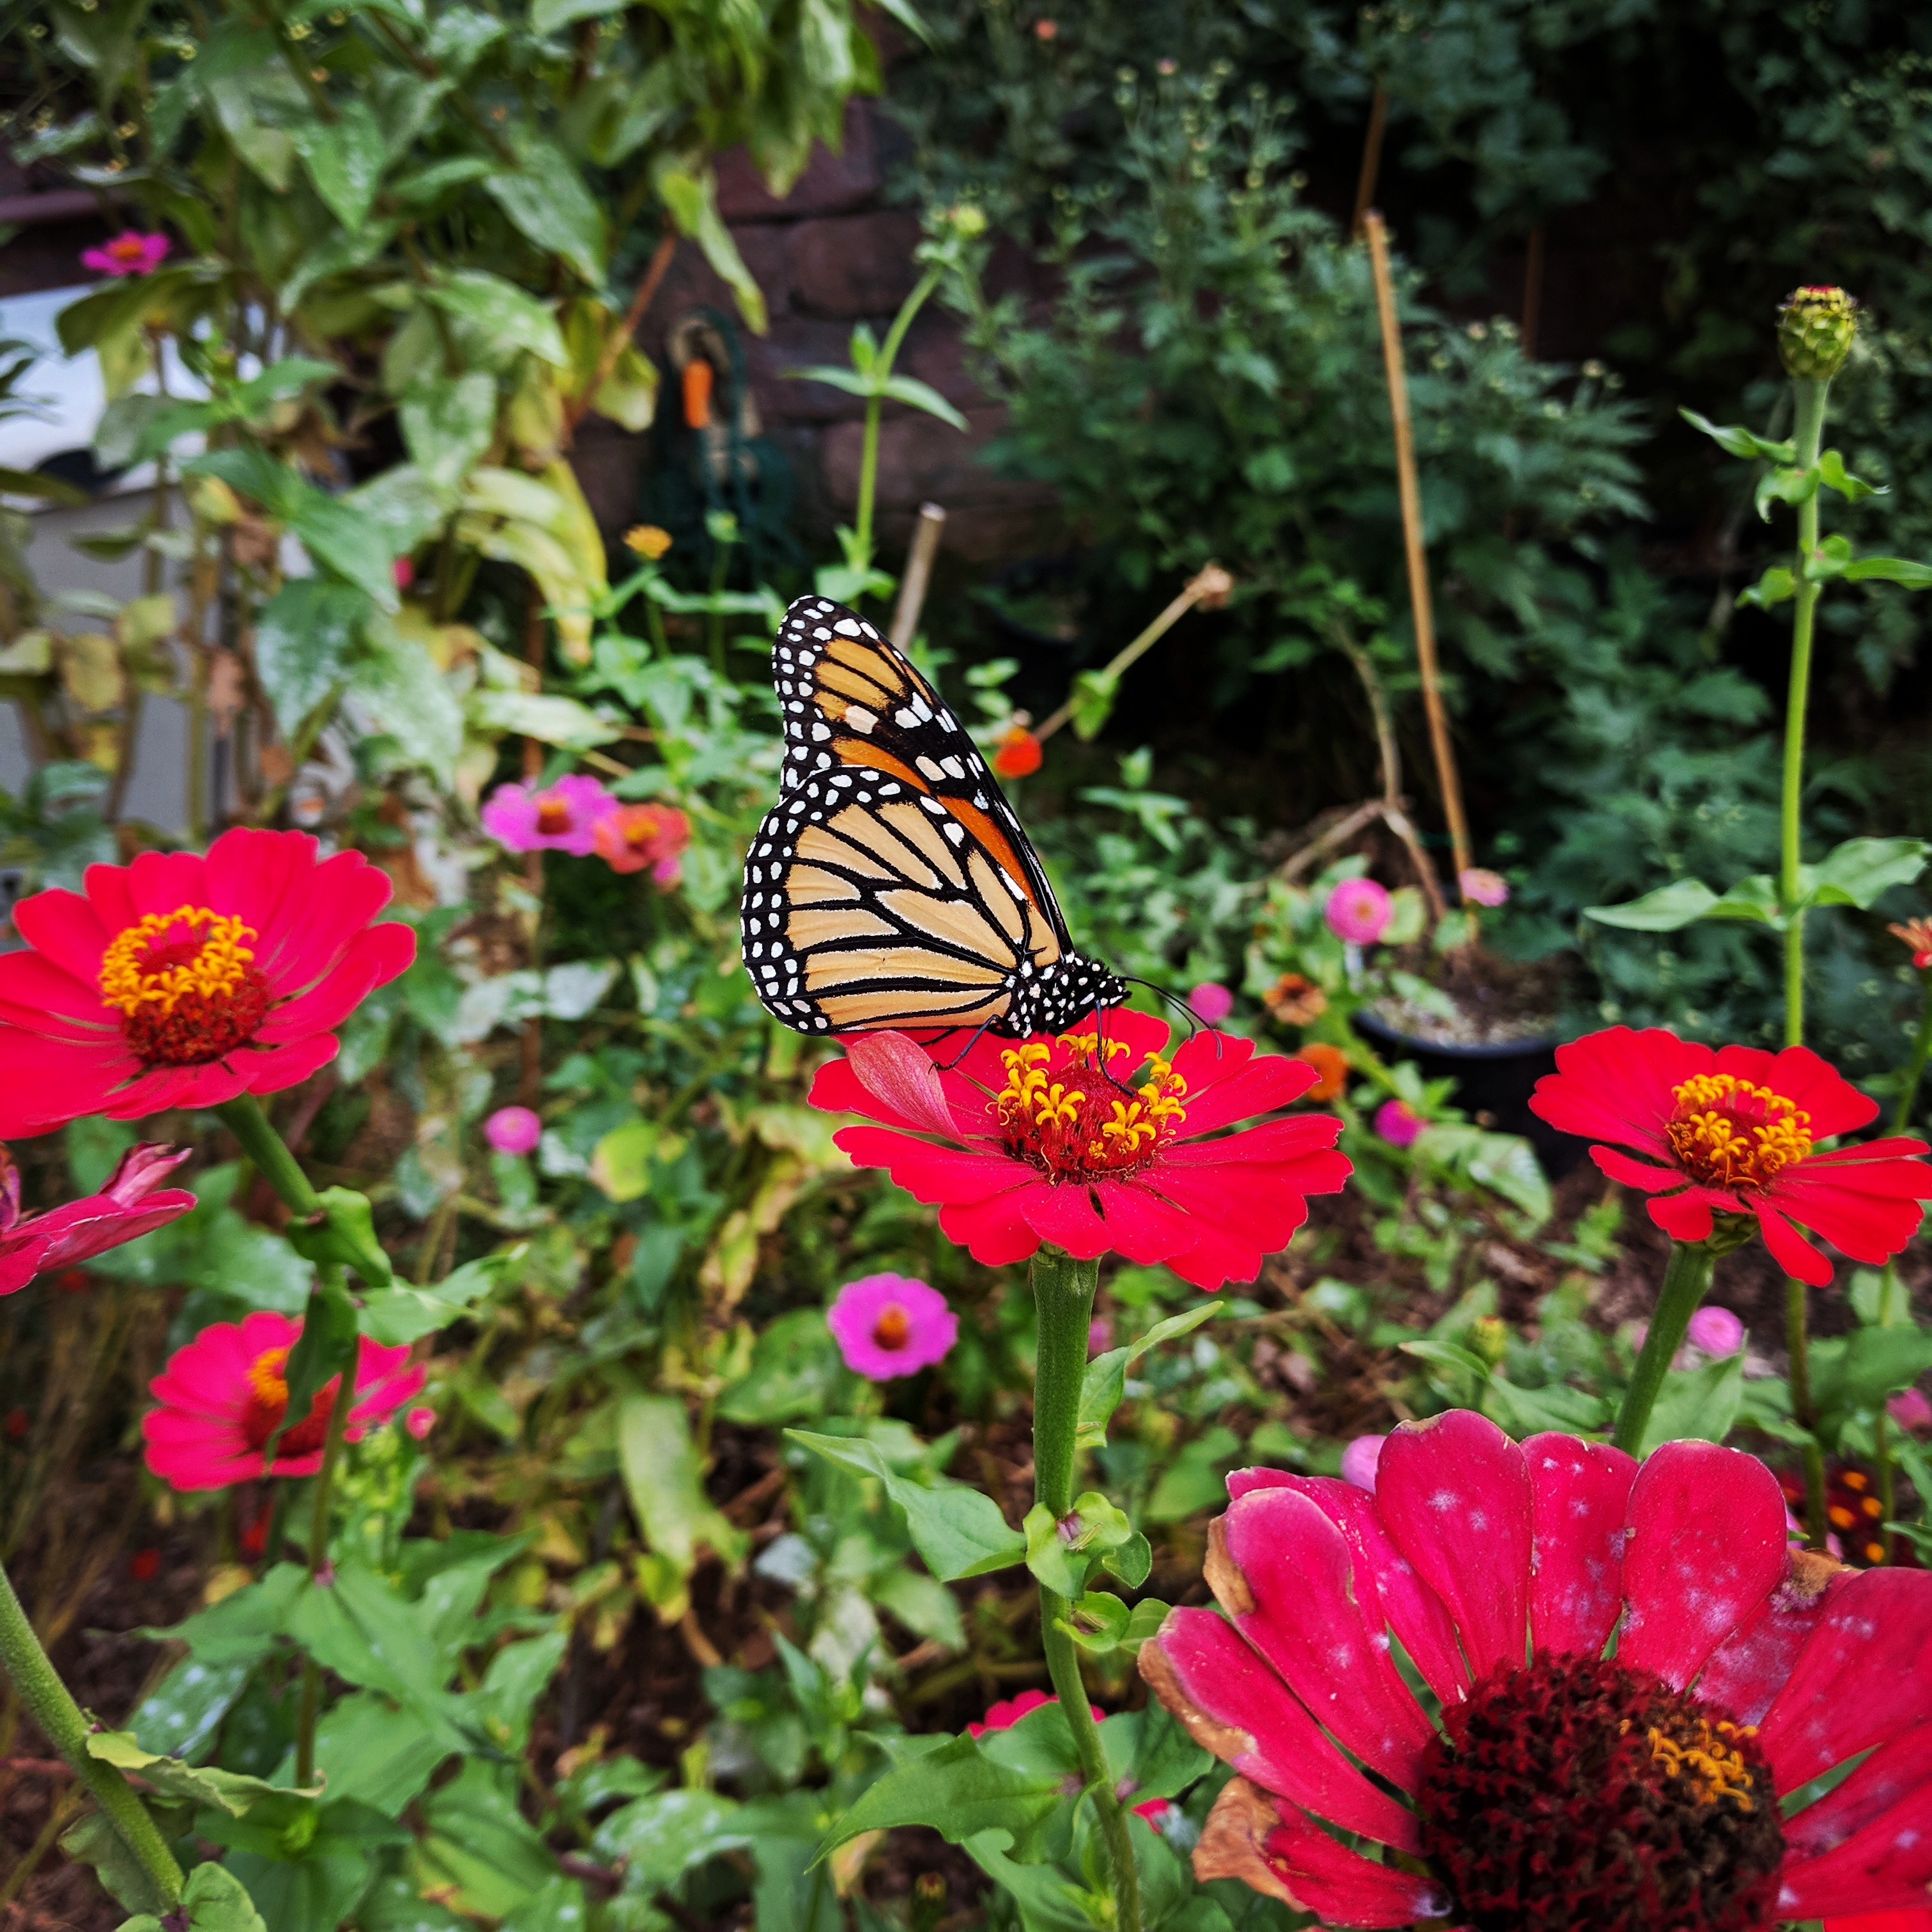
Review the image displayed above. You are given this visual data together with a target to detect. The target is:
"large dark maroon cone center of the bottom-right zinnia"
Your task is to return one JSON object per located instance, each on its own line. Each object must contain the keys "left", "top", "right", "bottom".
{"left": 1418, "top": 1656, "right": 1783, "bottom": 1932}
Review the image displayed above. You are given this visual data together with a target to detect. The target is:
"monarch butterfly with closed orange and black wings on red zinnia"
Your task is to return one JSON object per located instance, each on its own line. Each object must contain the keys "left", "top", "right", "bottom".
{"left": 742, "top": 597, "right": 1126, "bottom": 1039}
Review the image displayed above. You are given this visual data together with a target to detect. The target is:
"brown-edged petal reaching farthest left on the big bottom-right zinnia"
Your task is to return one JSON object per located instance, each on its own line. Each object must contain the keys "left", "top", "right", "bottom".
{"left": 1142, "top": 1609, "right": 1422, "bottom": 1853}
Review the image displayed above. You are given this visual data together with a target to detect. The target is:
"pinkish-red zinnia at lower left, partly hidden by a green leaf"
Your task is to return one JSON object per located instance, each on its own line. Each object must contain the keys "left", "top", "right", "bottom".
{"left": 141, "top": 1312, "right": 423, "bottom": 1490}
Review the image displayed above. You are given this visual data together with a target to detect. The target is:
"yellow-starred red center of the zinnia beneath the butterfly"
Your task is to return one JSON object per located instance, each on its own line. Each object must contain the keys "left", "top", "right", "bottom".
{"left": 995, "top": 1034, "right": 1188, "bottom": 1181}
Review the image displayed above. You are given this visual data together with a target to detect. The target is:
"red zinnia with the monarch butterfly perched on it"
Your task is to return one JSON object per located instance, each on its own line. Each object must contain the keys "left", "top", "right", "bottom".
{"left": 811, "top": 1009, "right": 1351, "bottom": 1289}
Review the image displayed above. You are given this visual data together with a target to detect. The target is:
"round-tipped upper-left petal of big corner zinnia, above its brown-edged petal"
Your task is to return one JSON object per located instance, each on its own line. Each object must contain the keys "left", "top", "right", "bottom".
{"left": 1211, "top": 1490, "right": 1436, "bottom": 1791}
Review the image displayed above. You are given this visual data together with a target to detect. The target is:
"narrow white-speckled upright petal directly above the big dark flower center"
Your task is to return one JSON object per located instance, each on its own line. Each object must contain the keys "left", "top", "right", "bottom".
{"left": 1530, "top": 1436, "right": 1636, "bottom": 1658}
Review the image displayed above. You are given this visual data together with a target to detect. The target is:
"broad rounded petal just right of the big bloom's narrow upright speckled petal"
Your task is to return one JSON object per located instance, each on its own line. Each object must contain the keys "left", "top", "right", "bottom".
{"left": 1617, "top": 1443, "right": 1785, "bottom": 1690}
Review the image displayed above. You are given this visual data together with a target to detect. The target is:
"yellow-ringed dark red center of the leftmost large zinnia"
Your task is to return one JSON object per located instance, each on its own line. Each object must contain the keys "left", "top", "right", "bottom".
{"left": 100, "top": 906, "right": 272, "bottom": 1066}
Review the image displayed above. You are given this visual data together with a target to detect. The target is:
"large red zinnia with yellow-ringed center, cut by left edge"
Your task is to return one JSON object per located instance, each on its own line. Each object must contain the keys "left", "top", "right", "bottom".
{"left": 0, "top": 829, "right": 415, "bottom": 1136}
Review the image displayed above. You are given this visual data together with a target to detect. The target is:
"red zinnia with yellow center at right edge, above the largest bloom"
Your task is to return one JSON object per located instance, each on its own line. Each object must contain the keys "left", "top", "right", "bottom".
{"left": 1530, "top": 1026, "right": 1932, "bottom": 1287}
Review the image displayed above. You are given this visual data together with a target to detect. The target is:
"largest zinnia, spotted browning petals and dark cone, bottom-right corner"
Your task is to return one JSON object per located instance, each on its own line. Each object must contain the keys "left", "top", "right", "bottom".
{"left": 1140, "top": 1411, "right": 1932, "bottom": 1932}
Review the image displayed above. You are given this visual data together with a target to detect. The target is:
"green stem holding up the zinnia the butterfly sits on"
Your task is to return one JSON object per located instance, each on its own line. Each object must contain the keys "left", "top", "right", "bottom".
{"left": 1032, "top": 1246, "right": 1140, "bottom": 1932}
